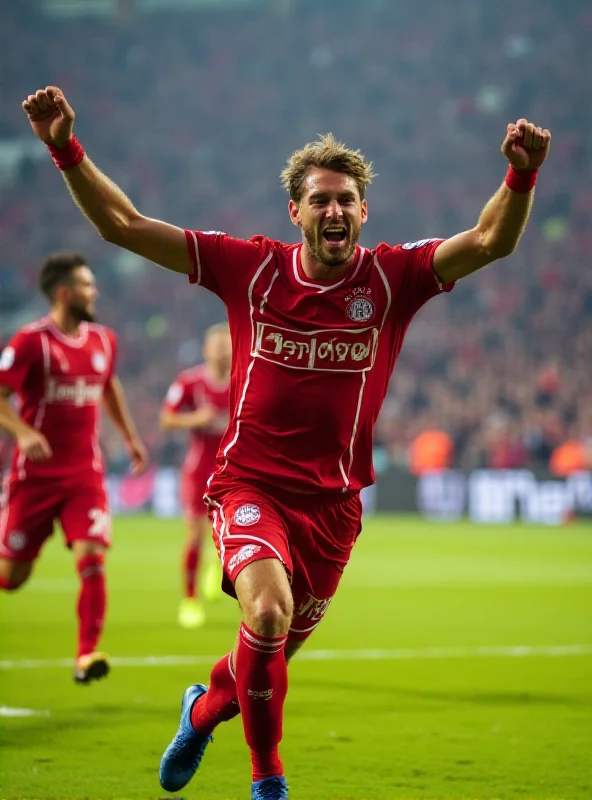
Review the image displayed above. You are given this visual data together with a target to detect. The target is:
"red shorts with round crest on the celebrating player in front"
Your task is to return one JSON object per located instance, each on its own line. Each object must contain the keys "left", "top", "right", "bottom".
{"left": 208, "top": 476, "right": 362, "bottom": 639}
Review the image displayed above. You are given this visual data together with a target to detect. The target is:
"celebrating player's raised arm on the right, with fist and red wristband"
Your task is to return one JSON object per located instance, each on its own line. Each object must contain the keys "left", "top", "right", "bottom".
{"left": 433, "top": 119, "right": 551, "bottom": 283}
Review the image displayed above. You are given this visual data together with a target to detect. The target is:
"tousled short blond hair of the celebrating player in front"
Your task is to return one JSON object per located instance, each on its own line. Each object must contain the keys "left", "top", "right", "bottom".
{"left": 281, "top": 133, "right": 375, "bottom": 203}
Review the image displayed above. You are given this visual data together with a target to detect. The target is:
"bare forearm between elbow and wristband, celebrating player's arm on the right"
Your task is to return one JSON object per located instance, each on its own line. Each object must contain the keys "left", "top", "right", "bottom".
{"left": 477, "top": 183, "right": 534, "bottom": 260}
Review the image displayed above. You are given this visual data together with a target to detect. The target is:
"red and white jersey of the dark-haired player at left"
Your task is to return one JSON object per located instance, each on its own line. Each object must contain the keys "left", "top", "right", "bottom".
{"left": 0, "top": 317, "right": 117, "bottom": 480}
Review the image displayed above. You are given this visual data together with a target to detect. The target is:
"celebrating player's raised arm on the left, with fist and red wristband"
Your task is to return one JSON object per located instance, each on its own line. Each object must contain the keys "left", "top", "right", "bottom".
{"left": 22, "top": 86, "right": 193, "bottom": 274}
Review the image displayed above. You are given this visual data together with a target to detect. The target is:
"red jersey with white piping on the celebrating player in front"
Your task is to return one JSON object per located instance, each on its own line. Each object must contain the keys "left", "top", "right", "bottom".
{"left": 185, "top": 230, "right": 452, "bottom": 492}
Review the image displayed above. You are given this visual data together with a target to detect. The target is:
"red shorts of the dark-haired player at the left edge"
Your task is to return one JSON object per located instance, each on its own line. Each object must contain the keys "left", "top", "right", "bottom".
{"left": 0, "top": 475, "right": 111, "bottom": 561}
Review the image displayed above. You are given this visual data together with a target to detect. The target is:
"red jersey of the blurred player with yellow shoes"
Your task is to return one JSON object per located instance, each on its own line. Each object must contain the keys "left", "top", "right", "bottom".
{"left": 163, "top": 364, "right": 230, "bottom": 472}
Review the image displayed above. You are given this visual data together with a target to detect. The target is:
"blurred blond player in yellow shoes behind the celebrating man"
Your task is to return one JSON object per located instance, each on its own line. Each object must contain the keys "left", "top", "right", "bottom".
{"left": 160, "top": 323, "right": 232, "bottom": 628}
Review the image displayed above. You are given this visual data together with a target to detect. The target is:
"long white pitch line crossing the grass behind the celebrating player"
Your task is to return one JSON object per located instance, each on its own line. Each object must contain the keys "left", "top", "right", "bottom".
{"left": 0, "top": 644, "right": 592, "bottom": 670}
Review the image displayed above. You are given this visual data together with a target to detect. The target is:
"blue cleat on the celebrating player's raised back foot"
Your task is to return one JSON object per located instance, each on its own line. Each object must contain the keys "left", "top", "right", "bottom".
{"left": 158, "top": 683, "right": 212, "bottom": 796}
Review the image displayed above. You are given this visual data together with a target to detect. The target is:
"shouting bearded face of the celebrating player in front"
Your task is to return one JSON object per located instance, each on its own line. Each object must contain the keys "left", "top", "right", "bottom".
{"left": 290, "top": 167, "right": 368, "bottom": 267}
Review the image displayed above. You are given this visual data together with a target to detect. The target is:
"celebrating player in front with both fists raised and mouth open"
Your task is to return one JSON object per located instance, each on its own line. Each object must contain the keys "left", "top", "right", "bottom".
{"left": 23, "top": 87, "right": 551, "bottom": 800}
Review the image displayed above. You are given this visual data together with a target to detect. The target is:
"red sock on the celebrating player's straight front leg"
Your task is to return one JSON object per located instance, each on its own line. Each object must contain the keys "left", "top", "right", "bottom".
{"left": 236, "top": 622, "right": 288, "bottom": 781}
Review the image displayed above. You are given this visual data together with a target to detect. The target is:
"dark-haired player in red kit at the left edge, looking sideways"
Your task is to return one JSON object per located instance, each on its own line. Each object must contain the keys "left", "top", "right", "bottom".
{"left": 0, "top": 253, "right": 147, "bottom": 683}
